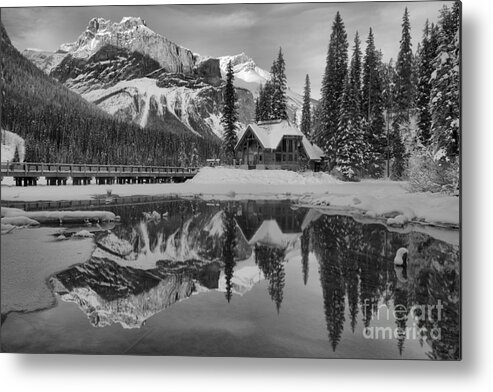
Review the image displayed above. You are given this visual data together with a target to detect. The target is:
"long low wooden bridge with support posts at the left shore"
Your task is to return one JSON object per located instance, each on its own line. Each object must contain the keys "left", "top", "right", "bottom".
{"left": 0, "top": 162, "right": 199, "bottom": 186}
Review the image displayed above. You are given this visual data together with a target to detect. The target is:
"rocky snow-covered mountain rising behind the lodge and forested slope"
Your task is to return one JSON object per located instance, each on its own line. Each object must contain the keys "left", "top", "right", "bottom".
{"left": 23, "top": 17, "right": 308, "bottom": 138}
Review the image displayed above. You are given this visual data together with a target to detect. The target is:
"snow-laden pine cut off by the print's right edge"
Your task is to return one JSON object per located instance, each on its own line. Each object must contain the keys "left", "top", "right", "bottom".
{"left": 430, "top": 1, "right": 461, "bottom": 157}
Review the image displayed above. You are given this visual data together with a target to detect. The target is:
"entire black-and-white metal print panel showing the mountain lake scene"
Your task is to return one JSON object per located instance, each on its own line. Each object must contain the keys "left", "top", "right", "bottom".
{"left": 0, "top": 1, "right": 461, "bottom": 360}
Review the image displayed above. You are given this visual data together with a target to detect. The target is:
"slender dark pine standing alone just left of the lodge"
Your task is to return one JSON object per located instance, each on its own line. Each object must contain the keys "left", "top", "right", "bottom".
{"left": 221, "top": 61, "right": 238, "bottom": 164}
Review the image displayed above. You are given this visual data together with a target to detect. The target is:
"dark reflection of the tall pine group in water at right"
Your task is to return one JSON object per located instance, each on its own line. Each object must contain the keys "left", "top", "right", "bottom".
{"left": 312, "top": 216, "right": 460, "bottom": 359}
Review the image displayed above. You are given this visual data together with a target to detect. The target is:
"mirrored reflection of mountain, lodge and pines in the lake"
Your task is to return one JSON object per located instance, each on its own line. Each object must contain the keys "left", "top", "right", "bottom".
{"left": 51, "top": 200, "right": 460, "bottom": 359}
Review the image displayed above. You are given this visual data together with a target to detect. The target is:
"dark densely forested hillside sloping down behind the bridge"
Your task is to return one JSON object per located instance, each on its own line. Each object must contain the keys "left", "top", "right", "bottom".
{"left": 0, "top": 24, "right": 219, "bottom": 165}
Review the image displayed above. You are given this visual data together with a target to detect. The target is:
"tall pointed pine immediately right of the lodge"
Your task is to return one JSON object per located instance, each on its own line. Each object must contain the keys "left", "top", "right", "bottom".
{"left": 315, "top": 12, "right": 348, "bottom": 167}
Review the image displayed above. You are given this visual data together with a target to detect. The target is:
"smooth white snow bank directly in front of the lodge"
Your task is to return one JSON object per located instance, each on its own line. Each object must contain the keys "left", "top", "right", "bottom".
{"left": 187, "top": 167, "right": 340, "bottom": 185}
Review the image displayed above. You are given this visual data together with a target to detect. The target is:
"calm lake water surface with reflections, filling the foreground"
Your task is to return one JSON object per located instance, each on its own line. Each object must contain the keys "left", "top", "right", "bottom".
{"left": 1, "top": 199, "right": 461, "bottom": 360}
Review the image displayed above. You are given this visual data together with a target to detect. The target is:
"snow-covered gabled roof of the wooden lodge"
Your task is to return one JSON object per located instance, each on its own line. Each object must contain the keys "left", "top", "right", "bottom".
{"left": 235, "top": 120, "right": 325, "bottom": 161}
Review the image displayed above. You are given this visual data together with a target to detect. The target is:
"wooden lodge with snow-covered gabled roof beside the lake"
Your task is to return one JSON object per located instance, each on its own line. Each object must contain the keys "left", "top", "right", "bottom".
{"left": 235, "top": 120, "right": 324, "bottom": 171}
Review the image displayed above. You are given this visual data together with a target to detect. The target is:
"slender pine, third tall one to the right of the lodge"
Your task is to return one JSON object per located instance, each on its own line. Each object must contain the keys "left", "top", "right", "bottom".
{"left": 361, "top": 28, "right": 387, "bottom": 177}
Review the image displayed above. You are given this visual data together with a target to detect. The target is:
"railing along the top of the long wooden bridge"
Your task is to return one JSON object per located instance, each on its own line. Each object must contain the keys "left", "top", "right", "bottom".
{"left": 0, "top": 162, "right": 199, "bottom": 177}
